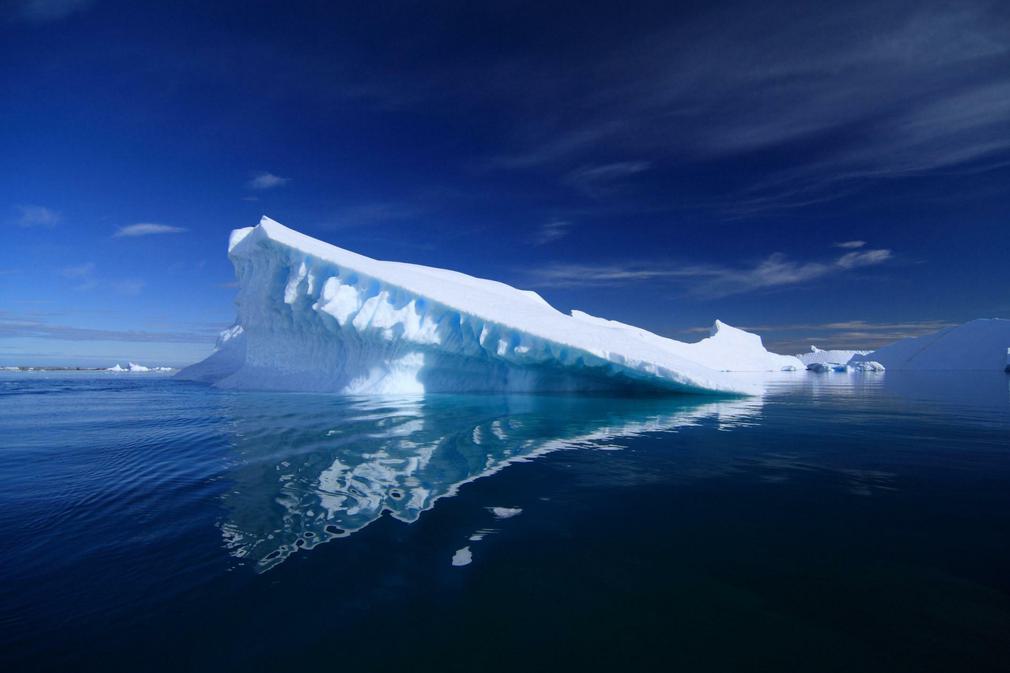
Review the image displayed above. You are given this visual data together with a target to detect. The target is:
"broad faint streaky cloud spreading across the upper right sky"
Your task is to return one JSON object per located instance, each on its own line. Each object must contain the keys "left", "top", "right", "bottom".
{"left": 482, "top": 0, "right": 1010, "bottom": 212}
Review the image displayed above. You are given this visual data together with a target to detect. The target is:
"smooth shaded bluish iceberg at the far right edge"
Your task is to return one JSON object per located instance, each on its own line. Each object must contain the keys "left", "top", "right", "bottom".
{"left": 851, "top": 318, "right": 1010, "bottom": 372}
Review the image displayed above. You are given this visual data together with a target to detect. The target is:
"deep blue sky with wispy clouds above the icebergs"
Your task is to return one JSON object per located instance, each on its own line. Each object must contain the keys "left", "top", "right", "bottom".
{"left": 0, "top": 0, "right": 1010, "bottom": 365}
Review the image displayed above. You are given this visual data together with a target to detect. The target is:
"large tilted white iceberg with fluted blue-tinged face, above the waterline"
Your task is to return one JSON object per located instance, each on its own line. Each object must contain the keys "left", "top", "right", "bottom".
{"left": 180, "top": 217, "right": 800, "bottom": 394}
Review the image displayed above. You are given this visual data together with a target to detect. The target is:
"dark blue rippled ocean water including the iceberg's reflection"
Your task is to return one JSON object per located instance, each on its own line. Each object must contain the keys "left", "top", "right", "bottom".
{"left": 0, "top": 372, "right": 1010, "bottom": 672}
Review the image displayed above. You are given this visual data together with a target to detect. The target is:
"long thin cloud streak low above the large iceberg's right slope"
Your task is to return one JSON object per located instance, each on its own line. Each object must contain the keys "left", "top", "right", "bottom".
{"left": 531, "top": 241, "right": 892, "bottom": 299}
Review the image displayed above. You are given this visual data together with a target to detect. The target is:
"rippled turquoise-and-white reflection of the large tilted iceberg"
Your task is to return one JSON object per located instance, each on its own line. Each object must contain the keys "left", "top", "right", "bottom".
{"left": 220, "top": 394, "right": 763, "bottom": 571}
